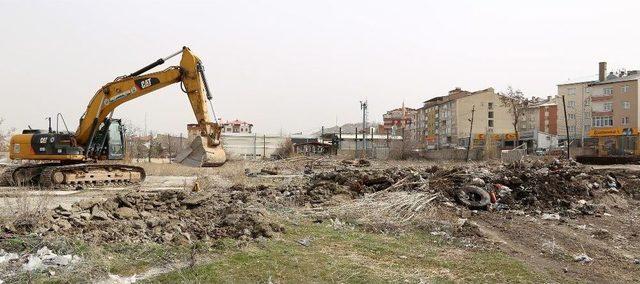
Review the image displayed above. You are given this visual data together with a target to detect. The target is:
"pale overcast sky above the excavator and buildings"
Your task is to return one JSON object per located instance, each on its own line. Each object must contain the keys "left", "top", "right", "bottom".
{"left": 0, "top": 0, "right": 640, "bottom": 134}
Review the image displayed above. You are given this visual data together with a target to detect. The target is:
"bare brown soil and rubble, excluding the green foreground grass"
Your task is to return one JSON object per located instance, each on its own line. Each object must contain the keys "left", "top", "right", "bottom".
{"left": 0, "top": 157, "right": 640, "bottom": 283}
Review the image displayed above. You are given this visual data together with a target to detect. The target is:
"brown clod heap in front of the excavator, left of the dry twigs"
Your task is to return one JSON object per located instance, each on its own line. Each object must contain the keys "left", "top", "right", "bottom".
{"left": 4, "top": 189, "right": 282, "bottom": 243}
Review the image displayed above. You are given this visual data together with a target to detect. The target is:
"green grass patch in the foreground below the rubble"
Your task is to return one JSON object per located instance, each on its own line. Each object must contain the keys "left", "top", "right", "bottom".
{"left": 147, "top": 223, "right": 544, "bottom": 283}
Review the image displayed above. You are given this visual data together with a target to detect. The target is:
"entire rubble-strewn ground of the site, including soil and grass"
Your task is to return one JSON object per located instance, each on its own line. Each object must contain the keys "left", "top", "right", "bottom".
{"left": 0, "top": 157, "right": 640, "bottom": 283}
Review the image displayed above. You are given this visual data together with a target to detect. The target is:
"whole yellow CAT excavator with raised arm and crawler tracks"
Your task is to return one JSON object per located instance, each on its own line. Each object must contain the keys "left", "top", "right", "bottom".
{"left": 0, "top": 47, "right": 226, "bottom": 188}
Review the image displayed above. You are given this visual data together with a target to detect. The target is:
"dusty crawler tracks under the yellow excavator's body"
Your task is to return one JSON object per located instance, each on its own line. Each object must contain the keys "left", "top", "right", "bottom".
{"left": 0, "top": 164, "right": 146, "bottom": 189}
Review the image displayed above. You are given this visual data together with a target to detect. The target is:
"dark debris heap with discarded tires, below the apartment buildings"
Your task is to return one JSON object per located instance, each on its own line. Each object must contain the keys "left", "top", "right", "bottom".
{"left": 264, "top": 159, "right": 640, "bottom": 214}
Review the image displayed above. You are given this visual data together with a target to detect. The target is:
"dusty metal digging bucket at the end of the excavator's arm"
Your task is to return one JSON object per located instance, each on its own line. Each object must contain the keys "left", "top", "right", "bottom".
{"left": 176, "top": 136, "right": 227, "bottom": 167}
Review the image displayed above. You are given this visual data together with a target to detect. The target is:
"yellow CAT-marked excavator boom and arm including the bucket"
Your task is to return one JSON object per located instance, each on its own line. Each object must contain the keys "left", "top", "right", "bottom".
{"left": 75, "top": 47, "right": 226, "bottom": 166}
